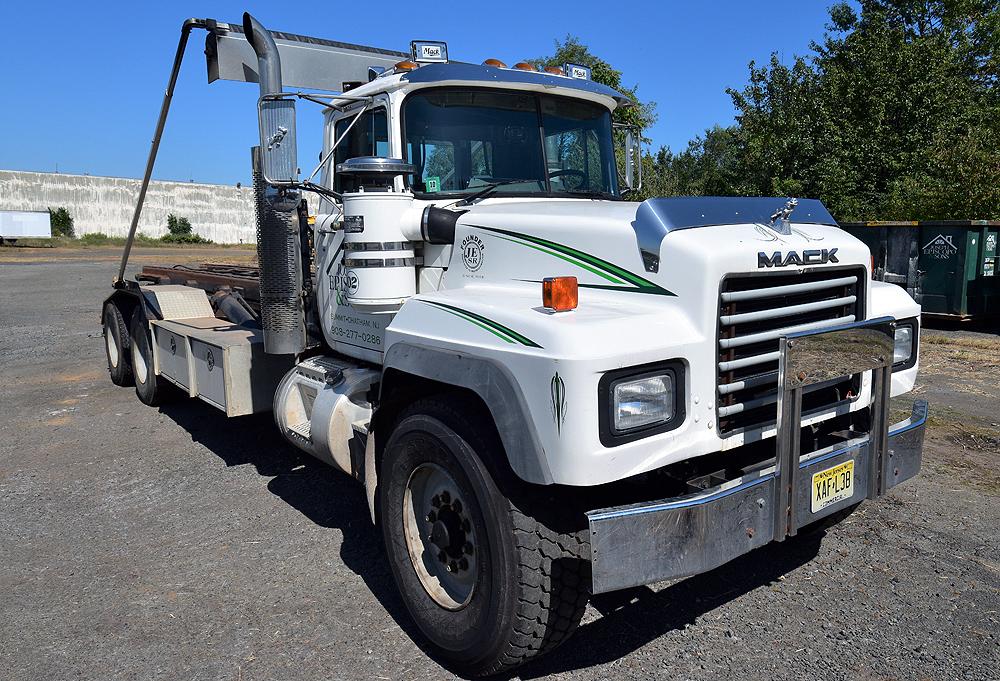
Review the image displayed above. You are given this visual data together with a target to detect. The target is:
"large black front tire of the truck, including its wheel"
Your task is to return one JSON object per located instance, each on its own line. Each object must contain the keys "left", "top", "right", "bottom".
{"left": 378, "top": 399, "right": 589, "bottom": 676}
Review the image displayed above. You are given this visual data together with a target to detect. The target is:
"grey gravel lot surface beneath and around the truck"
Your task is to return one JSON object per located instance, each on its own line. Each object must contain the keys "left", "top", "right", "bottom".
{"left": 0, "top": 249, "right": 1000, "bottom": 680}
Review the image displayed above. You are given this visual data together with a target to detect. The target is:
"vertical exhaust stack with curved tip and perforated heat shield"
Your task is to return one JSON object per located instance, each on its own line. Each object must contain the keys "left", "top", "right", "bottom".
{"left": 243, "top": 12, "right": 306, "bottom": 355}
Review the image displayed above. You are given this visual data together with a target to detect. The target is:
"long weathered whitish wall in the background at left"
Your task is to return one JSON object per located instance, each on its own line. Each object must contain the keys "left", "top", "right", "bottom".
{"left": 0, "top": 170, "right": 258, "bottom": 243}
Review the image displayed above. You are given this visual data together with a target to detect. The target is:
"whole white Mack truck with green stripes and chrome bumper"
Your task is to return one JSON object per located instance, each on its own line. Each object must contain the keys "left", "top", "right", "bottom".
{"left": 102, "top": 15, "right": 927, "bottom": 674}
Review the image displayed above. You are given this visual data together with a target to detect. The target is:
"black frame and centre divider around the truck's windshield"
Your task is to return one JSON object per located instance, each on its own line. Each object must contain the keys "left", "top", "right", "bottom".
{"left": 399, "top": 85, "right": 624, "bottom": 201}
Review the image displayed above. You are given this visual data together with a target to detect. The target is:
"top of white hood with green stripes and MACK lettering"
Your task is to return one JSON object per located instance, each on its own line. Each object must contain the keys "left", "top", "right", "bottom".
{"left": 448, "top": 199, "right": 870, "bottom": 300}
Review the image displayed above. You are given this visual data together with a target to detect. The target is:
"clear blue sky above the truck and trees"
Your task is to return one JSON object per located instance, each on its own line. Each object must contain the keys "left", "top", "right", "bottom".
{"left": 0, "top": 0, "right": 833, "bottom": 183}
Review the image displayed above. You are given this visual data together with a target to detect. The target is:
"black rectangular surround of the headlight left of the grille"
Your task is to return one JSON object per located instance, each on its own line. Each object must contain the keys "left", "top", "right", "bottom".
{"left": 597, "top": 360, "right": 687, "bottom": 447}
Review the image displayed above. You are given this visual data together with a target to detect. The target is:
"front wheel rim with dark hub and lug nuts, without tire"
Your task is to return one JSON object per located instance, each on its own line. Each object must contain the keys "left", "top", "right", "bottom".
{"left": 403, "top": 463, "right": 478, "bottom": 610}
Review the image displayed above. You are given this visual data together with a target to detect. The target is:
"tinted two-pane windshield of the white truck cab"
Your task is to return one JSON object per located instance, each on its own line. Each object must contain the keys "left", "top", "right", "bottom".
{"left": 403, "top": 88, "right": 618, "bottom": 198}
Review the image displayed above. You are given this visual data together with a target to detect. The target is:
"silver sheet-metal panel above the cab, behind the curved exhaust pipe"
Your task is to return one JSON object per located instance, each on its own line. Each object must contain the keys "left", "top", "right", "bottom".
{"left": 205, "top": 21, "right": 410, "bottom": 92}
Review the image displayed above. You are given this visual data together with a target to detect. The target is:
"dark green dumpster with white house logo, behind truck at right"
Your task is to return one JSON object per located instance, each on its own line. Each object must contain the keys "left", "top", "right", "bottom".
{"left": 840, "top": 220, "right": 1000, "bottom": 319}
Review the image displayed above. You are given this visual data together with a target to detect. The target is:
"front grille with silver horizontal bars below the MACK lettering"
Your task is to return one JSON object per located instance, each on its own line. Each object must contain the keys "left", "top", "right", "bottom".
{"left": 717, "top": 268, "right": 865, "bottom": 435}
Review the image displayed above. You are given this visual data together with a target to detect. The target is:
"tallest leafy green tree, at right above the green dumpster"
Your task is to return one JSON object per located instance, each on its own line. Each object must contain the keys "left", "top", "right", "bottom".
{"left": 728, "top": 0, "right": 1000, "bottom": 220}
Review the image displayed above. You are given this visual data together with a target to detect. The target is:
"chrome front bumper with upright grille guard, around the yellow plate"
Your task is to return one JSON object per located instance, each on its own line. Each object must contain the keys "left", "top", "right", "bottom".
{"left": 587, "top": 320, "right": 927, "bottom": 593}
